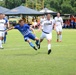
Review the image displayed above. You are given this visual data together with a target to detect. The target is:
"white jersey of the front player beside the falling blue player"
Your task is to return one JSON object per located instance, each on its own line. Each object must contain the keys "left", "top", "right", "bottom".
{"left": 42, "top": 20, "right": 54, "bottom": 33}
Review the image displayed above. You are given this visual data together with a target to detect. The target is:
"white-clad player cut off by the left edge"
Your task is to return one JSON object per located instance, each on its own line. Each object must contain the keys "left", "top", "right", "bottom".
{"left": 0, "top": 13, "right": 6, "bottom": 49}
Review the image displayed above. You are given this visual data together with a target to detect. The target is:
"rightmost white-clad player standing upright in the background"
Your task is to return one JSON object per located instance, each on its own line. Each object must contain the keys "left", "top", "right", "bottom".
{"left": 54, "top": 13, "right": 63, "bottom": 42}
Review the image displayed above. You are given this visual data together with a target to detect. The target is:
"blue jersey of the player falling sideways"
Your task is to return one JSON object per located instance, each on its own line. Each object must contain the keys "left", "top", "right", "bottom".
{"left": 14, "top": 24, "right": 31, "bottom": 36}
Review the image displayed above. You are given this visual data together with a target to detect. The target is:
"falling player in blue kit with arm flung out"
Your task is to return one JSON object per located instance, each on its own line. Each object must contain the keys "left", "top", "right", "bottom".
{"left": 6, "top": 20, "right": 40, "bottom": 50}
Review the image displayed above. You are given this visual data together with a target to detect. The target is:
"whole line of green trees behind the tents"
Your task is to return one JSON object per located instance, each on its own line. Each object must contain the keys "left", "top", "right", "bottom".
{"left": 0, "top": 0, "right": 76, "bottom": 15}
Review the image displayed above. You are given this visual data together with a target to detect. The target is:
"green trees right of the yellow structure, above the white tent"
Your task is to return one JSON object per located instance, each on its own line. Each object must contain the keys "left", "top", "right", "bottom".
{"left": 45, "top": 0, "right": 76, "bottom": 14}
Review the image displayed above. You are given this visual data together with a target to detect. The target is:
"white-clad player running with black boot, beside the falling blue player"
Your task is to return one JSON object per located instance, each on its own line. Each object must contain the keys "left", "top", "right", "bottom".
{"left": 40, "top": 14, "right": 54, "bottom": 54}
